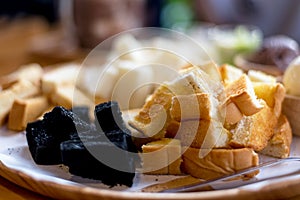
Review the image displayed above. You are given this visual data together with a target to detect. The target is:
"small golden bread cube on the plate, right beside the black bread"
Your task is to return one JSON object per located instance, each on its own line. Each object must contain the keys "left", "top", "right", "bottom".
{"left": 141, "top": 138, "right": 182, "bottom": 175}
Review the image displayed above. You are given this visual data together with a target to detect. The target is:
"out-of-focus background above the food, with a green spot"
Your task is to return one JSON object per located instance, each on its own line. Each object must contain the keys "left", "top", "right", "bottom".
{"left": 0, "top": 0, "right": 300, "bottom": 73}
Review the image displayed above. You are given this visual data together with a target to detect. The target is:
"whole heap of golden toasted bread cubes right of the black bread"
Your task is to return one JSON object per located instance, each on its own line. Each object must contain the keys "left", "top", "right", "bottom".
{"left": 128, "top": 63, "right": 292, "bottom": 180}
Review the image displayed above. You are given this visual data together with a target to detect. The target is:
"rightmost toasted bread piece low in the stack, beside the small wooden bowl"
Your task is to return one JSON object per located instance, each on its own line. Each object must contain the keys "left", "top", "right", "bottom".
{"left": 260, "top": 115, "right": 293, "bottom": 158}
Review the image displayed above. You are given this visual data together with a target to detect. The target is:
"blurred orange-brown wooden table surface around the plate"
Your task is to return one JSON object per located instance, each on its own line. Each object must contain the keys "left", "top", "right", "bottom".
{"left": 0, "top": 16, "right": 300, "bottom": 200}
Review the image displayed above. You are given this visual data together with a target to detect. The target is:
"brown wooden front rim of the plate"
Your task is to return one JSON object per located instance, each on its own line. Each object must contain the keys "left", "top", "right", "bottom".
{"left": 0, "top": 157, "right": 300, "bottom": 200}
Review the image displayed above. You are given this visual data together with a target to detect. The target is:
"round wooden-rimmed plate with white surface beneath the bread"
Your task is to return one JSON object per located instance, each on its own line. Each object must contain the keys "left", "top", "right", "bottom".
{"left": 0, "top": 127, "right": 300, "bottom": 200}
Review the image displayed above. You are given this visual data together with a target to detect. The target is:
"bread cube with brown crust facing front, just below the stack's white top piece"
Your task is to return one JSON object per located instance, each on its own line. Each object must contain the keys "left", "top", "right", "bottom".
{"left": 170, "top": 93, "right": 211, "bottom": 122}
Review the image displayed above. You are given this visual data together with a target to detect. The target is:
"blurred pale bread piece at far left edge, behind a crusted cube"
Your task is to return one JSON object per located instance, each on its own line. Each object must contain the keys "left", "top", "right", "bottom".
{"left": 0, "top": 80, "right": 39, "bottom": 125}
